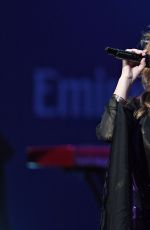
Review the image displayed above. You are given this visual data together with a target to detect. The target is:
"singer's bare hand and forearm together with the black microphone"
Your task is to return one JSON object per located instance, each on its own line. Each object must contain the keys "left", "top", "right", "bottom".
{"left": 106, "top": 48, "right": 150, "bottom": 100}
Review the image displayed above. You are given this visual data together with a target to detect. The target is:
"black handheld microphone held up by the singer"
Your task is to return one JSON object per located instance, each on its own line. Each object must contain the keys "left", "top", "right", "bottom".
{"left": 105, "top": 47, "right": 150, "bottom": 68}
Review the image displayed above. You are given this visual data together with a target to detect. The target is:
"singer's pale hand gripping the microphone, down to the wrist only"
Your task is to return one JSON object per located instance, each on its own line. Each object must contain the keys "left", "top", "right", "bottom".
{"left": 121, "top": 49, "right": 147, "bottom": 84}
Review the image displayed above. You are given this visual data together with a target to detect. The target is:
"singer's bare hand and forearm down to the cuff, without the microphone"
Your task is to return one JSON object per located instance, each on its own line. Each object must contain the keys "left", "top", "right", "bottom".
{"left": 114, "top": 49, "right": 147, "bottom": 100}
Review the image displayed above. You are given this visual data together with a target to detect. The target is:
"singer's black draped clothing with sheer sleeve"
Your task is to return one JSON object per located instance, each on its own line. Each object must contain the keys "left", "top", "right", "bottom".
{"left": 96, "top": 97, "right": 150, "bottom": 230}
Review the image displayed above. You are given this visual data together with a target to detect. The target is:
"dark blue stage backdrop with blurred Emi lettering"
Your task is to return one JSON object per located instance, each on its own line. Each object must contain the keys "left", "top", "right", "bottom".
{"left": 0, "top": 0, "right": 149, "bottom": 230}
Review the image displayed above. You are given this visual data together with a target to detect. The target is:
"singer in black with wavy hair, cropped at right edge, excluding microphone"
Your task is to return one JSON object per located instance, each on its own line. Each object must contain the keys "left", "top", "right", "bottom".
{"left": 96, "top": 31, "right": 150, "bottom": 230}
